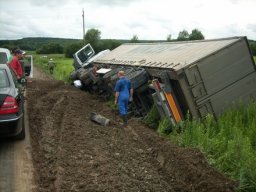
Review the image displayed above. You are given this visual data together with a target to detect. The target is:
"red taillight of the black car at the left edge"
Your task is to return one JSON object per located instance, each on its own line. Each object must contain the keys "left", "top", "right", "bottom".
{"left": 0, "top": 96, "right": 19, "bottom": 115}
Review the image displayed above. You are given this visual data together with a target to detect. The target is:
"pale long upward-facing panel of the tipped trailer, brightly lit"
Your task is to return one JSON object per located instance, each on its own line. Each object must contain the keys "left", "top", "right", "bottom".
{"left": 95, "top": 37, "right": 246, "bottom": 71}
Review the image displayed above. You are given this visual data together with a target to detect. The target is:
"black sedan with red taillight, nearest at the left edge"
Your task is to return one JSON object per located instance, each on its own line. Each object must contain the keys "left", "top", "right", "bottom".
{"left": 0, "top": 64, "right": 25, "bottom": 139}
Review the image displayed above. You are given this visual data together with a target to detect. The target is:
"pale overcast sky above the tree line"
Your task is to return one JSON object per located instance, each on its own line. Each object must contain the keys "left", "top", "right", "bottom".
{"left": 0, "top": 0, "right": 256, "bottom": 40}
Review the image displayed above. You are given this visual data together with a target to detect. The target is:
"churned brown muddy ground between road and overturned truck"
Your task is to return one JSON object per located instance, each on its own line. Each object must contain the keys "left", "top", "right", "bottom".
{"left": 27, "top": 66, "right": 236, "bottom": 192}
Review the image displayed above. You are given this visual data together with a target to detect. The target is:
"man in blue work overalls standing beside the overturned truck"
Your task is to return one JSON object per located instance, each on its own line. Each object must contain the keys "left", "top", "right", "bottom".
{"left": 115, "top": 71, "right": 133, "bottom": 125}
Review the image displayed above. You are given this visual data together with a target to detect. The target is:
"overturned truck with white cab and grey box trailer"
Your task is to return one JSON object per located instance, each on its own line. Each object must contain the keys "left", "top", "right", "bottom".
{"left": 71, "top": 37, "right": 256, "bottom": 124}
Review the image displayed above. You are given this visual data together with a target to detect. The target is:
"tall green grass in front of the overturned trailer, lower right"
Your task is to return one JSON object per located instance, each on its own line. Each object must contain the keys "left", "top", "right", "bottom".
{"left": 145, "top": 102, "right": 256, "bottom": 192}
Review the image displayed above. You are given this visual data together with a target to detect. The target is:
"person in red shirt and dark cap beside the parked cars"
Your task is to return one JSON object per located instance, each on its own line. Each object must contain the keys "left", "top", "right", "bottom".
{"left": 9, "top": 49, "right": 24, "bottom": 83}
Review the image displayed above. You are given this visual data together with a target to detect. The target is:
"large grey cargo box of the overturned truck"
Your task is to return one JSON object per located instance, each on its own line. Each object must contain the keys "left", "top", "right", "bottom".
{"left": 95, "top": 37, "right": 256, "bottom": 118}
